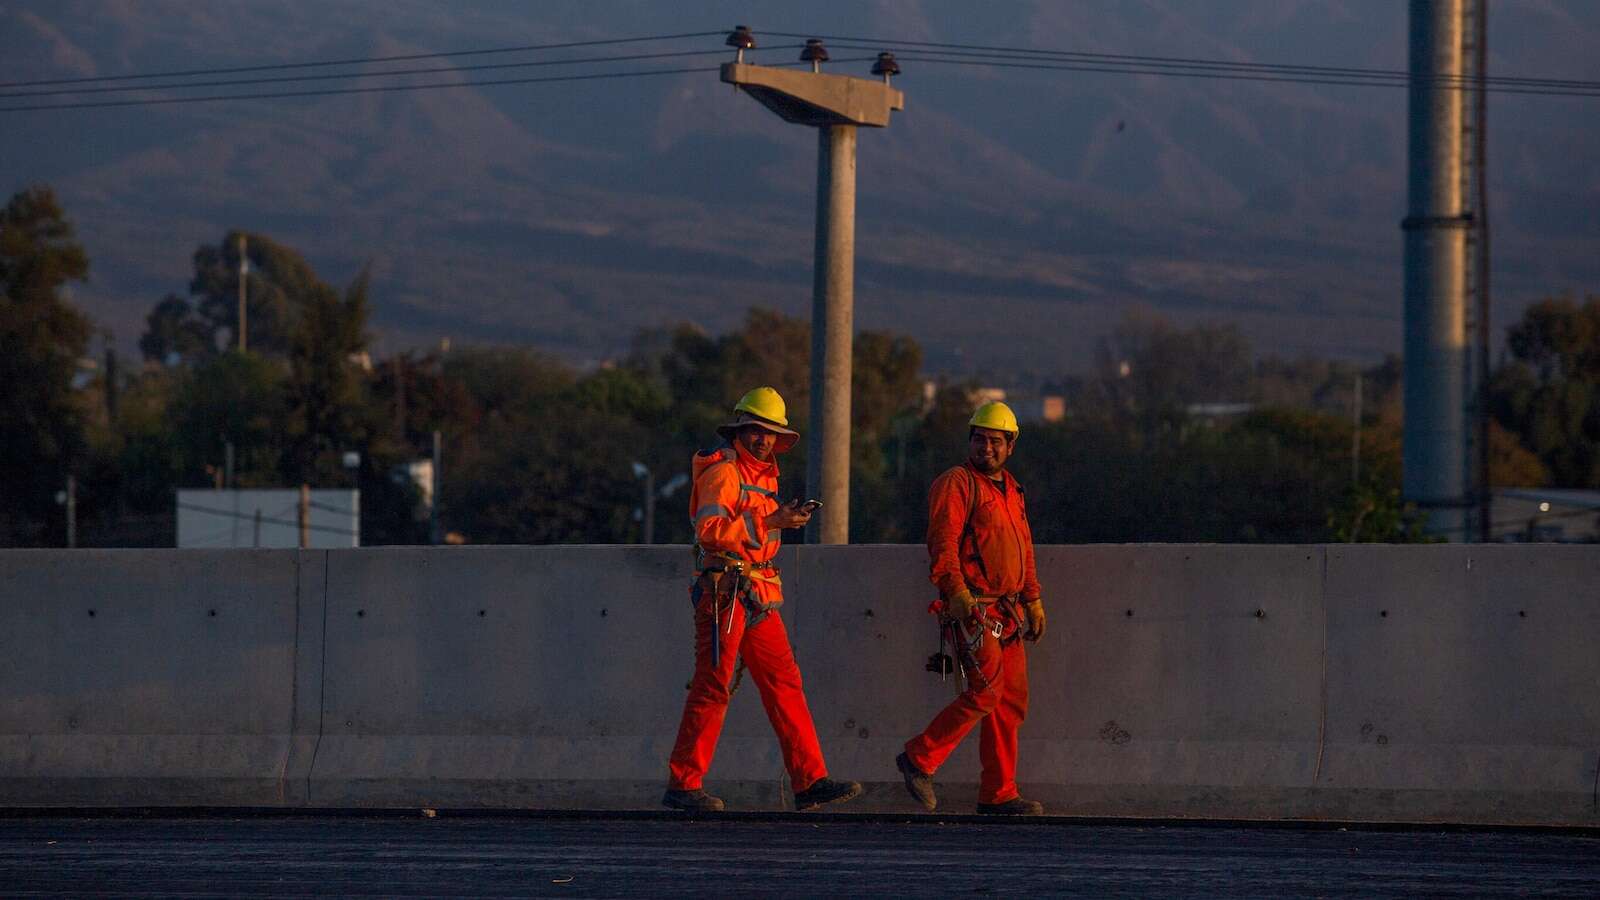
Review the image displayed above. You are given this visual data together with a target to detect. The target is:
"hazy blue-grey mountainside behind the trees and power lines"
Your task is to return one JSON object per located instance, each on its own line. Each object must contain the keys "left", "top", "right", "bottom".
{"left": 0, "top": 0, "right": 1600, "bottom": 378}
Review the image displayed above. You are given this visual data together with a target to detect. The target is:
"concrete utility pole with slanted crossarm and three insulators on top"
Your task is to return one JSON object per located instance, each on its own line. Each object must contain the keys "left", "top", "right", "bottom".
{"left": 722, "top": 26, "right": 906, "bottom": 544}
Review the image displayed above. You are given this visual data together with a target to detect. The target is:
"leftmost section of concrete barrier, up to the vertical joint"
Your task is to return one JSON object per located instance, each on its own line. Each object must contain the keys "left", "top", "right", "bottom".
{"left": 0, "top": 551, "right": 322, "bottom": 806}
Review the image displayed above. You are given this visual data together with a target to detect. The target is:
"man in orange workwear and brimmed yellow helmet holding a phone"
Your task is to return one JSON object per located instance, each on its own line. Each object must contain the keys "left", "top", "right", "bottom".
{"left": 661, "top": 388, "right": 861, "bottom": 812}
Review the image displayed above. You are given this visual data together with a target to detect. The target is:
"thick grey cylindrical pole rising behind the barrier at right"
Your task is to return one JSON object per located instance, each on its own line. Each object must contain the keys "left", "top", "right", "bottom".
{"left": 1402, "top": 0, "right": 1470, "bottom": 540}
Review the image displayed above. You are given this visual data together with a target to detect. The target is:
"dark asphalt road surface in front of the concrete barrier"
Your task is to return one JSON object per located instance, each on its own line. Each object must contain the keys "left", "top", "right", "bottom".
{"left": 0, "top": 814, "right": 1600, "bottom": 897}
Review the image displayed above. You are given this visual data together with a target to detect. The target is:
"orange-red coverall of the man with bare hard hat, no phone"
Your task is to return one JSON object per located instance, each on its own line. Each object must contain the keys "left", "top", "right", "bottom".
{"left": 906, "top": 463, "right": 1038, "bottom": 804}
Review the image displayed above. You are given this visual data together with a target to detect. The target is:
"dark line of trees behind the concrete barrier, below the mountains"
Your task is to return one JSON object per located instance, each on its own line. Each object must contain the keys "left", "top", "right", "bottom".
{"left": 0, "top": 187, "right": 1600, "bottom": 546}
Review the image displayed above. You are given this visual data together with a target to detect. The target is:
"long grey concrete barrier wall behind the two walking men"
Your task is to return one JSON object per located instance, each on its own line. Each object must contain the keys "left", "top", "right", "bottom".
{"left": 0, "top": 544, "right": 1600, "bottom": 825}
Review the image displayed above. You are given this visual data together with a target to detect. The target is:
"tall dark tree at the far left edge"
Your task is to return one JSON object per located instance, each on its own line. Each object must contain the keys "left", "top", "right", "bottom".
{"left": 0, "top": 187, "right": 90, "bottom": 543}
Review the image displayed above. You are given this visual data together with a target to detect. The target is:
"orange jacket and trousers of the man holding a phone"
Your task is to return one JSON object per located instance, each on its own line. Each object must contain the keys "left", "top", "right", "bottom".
{"left": 669, "top": 447, "right": 827, "bottom": 793}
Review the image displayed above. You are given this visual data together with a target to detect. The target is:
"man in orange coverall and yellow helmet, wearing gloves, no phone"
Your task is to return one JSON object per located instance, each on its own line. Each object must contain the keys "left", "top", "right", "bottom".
{"left": 894, "top": 402, "right": 1045, "bottom": 815}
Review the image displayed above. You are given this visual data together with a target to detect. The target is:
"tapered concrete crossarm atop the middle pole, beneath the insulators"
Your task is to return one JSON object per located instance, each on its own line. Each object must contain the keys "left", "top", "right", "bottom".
{"left": 722, "top": 62, "right": 906, "bottom": 128}
